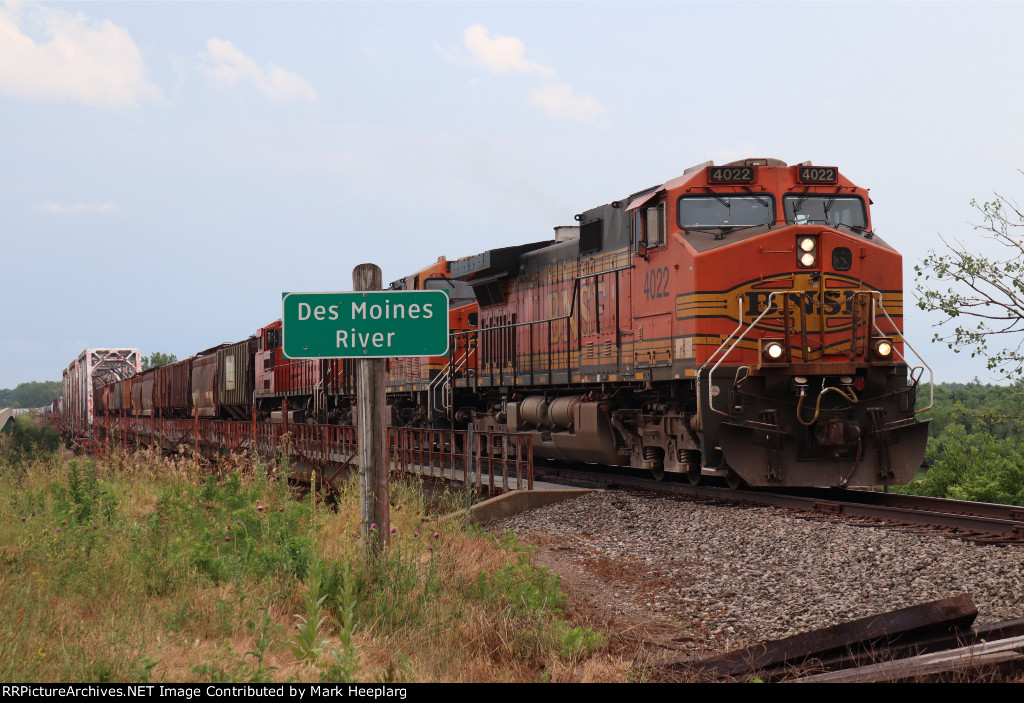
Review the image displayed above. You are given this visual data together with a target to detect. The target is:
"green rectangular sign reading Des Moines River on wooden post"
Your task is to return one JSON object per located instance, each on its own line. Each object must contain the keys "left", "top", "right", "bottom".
{"left": 281, "top": 291, "right": 449, "bottom": 359}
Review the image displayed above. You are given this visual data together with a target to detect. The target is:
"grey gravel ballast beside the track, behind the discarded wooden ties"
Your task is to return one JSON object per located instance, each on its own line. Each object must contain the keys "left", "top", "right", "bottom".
{"left": 490, "top": 491, "right": 1024, "bottom": 650}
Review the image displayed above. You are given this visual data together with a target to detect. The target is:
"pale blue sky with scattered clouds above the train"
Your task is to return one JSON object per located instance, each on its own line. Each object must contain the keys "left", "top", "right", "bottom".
{"left": 0, "top": 0, "right": 1024, "bottom": 388}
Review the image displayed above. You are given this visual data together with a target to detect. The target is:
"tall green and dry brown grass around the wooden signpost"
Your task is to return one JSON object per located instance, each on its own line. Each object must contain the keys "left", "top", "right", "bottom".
{"left": 0, "top": 421, "right": 614, "bottom": 682}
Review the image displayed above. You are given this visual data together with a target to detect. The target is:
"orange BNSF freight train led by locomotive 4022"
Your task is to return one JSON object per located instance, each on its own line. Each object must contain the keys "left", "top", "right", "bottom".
{"left": 70, "top": 159, "right": 930, "bottom": 486}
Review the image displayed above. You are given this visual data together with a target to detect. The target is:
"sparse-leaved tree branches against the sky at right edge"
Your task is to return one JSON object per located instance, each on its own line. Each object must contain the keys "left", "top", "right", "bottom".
{"left": 914, "top": 181, "right": 1024, "bottom": 379}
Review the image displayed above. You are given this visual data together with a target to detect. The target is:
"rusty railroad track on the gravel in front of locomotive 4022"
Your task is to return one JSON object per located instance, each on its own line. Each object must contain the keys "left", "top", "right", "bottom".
{"left": 535, "top": 464, "right": 1024, "bottom": 544}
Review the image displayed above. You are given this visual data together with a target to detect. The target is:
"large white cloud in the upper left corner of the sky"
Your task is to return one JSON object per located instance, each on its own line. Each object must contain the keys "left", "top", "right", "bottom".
{"left": 0, "top": 4, "right": 161, "bottom": 107}
